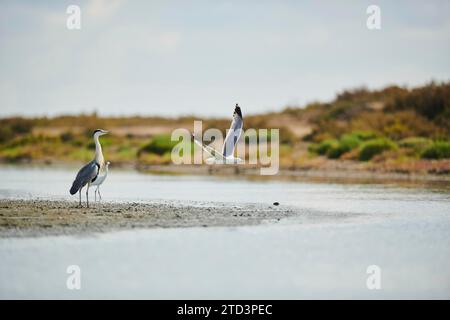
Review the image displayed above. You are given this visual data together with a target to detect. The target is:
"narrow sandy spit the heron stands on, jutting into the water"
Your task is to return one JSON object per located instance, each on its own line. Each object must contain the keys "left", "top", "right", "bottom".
{"left": 0, "top": 199, "right": 327, "bottom": 238}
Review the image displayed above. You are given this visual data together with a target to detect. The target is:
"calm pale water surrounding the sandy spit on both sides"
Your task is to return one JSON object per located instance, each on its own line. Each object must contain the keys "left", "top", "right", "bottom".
{"left": 0, "top": 167, "right": 450, "bottom": 299}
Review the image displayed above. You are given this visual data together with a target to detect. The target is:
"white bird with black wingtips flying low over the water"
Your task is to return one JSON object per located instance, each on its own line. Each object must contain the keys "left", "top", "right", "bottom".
{"left": 192, "top": 103, "right": 244, "bottom": 164}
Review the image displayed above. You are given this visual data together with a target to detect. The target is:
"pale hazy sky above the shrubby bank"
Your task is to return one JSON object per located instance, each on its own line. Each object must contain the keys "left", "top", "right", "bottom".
{"left": 0, "top": 0, "right": 450, "bottom": 116}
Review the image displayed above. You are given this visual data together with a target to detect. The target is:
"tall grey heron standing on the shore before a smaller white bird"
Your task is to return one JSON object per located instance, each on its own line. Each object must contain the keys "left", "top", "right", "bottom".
{"left": 70, "top": 129, "right": 108, "bottom": 208}
